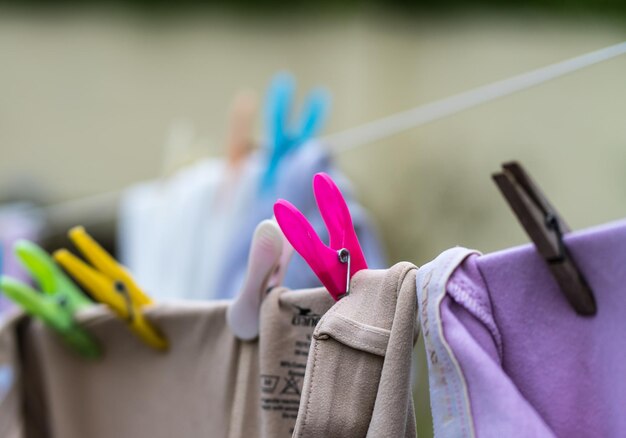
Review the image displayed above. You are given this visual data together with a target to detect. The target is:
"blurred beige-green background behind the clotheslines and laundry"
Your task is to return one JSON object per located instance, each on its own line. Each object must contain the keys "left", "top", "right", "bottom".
{"left": 0, "top": 0, "right": 626, "bottom": 436}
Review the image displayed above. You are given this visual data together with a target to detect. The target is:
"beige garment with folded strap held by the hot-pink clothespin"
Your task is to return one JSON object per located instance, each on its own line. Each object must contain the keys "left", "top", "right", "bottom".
{"left": 293, "top": 263, "right": 419, "bottom": 438}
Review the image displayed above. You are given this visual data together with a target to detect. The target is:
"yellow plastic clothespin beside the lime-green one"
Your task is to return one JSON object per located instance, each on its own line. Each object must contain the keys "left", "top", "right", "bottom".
{"left": 54, "top": 227, "right": 168, "bottom": 350}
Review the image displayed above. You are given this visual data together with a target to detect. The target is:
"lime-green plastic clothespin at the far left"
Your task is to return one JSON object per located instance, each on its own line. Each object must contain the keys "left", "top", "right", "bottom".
{"left": 0, "top": 240, "right": 100, "bottom": 359}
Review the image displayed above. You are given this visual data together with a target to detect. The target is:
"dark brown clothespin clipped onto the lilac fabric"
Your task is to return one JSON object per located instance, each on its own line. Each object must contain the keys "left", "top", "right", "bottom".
{"left": 492, "top": 162, "right": 596, "bottom": 315}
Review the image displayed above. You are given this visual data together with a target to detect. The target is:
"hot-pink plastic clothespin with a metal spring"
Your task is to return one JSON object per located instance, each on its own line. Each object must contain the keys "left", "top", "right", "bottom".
{"left": 274, "top": 173, "right": 367, "bottom": 300}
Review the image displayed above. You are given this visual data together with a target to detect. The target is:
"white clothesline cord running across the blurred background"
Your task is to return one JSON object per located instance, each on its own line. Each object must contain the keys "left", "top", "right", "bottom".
{"left": 39, "top": 41, "right": 626, "bottom": 223}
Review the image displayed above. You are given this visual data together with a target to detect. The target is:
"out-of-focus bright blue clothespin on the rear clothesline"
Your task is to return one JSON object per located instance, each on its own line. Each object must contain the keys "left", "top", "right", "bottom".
{"left": 261, "top": 72, "right": 330, "bottom": 191}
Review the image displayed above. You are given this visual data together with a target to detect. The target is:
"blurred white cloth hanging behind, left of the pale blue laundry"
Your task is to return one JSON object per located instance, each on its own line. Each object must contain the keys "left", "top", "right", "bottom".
{"left": 118, "top": 159, "right": 224, "bottom": 299}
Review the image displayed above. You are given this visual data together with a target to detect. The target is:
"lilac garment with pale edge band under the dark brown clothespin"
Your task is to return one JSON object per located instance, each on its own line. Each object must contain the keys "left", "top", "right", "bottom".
{"left": 417, "top": 221, "right": 626, "bottom": 437}
